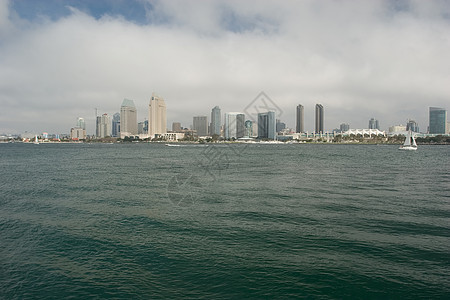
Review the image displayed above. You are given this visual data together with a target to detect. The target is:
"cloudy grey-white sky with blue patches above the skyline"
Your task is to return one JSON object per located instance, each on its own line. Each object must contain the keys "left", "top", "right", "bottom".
{"left": 0, "top": 0, "right": 450, "bottom": 134}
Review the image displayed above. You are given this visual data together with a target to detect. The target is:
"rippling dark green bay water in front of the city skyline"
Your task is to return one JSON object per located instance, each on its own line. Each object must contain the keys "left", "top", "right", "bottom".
{"left": 0, "top": 143, "right": 450, "bottom": 299}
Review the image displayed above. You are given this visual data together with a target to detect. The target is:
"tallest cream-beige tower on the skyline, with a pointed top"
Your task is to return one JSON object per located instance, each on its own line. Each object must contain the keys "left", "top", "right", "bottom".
{"left": 148, "top": 93, "right": 167, "bottom": 136}
